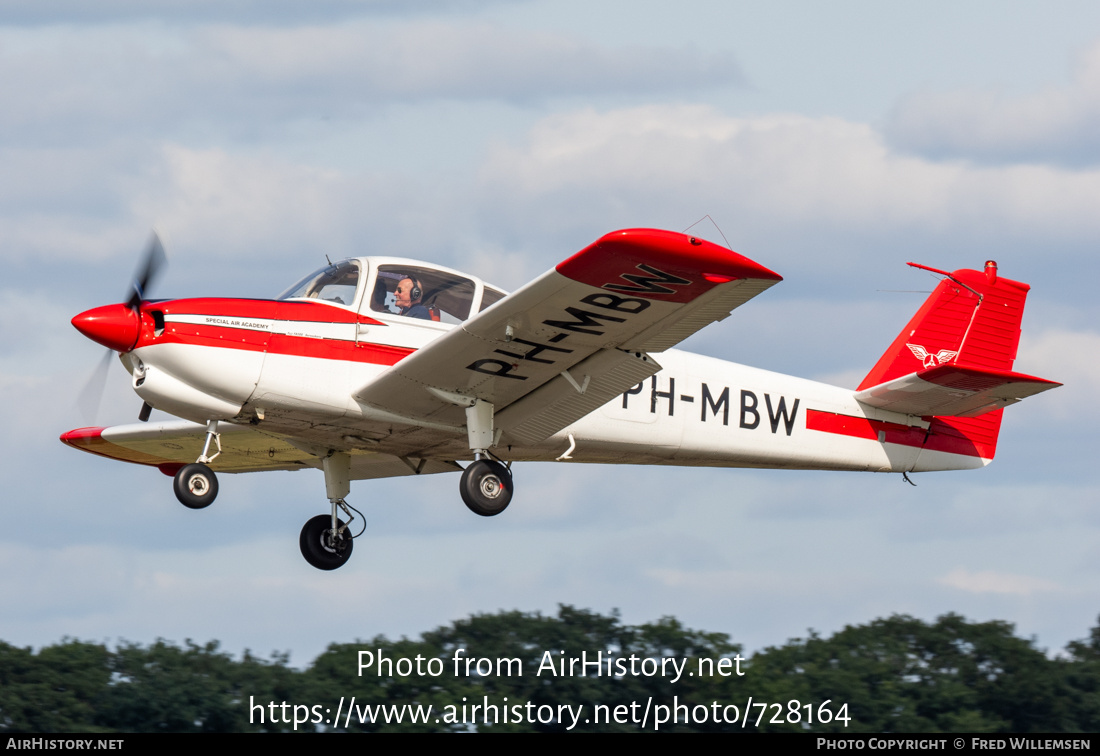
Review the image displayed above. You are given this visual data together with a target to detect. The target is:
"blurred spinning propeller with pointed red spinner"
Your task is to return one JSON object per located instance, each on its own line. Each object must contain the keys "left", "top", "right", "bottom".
{"left": 73, "top": 230, "right": 168, "bottom": 423}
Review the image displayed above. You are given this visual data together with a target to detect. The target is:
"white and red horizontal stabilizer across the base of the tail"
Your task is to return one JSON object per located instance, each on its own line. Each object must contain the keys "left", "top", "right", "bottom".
{"left": 856, "top": 365, "right": 1062, "bottom": 417}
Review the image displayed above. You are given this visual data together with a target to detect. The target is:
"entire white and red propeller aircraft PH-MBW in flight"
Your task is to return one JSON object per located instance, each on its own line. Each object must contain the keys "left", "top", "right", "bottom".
{"left": 62, "top": 229, "right": 1060, "bottom": 570}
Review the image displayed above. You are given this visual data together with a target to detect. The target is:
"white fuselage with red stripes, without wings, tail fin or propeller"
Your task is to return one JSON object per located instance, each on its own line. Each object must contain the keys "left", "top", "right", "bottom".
{"left": 81, "top": 259, "right": 993, "bottom": 472}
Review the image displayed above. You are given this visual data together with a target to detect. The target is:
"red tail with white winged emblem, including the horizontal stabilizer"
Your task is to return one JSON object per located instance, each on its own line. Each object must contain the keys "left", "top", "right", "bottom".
{"left": 856, "top": 260, "right": 1060, "bottom": 460}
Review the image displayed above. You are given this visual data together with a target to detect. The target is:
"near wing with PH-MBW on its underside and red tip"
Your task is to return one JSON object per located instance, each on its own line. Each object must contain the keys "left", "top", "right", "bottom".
{"left": 354, "top": 229, "right": 782, "bottom": 443}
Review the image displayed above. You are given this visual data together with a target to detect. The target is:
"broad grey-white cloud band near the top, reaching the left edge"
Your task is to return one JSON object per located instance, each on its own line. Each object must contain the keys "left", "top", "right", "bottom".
{"left": 0, "top": 19, "right": 743, "bottom": 144}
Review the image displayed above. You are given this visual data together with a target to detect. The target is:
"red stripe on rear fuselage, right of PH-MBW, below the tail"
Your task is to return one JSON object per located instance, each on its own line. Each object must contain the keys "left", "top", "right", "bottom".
{"left": 806, "top": 409, "right": 1000, "bottom": 459}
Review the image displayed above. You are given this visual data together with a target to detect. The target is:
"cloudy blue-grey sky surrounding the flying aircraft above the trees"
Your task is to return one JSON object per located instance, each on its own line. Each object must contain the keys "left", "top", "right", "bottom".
{"left": 0, "top": 0, "right": 1100, "bottom": 665}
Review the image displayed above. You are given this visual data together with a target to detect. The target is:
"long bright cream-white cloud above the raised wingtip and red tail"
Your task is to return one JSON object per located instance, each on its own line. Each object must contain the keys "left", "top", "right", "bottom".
{"left": 483, "top": 106, "right": 1100, "bottom": 238}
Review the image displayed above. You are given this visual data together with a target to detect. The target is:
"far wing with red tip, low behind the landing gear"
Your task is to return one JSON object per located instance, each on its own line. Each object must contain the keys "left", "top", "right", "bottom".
{"left": 62, "top": 420, "right": 461, "bottom": 480}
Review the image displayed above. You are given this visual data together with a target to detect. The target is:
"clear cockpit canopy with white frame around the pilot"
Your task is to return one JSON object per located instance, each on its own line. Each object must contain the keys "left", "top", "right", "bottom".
{"left": 278, "top": 258, "right": 506, "bottom": 325}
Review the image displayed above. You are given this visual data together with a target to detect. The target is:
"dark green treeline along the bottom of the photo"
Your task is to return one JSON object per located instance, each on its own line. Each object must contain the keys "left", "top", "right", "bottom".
{"left": 0, "top": 606, "right": 1100, "bottom": 733}
